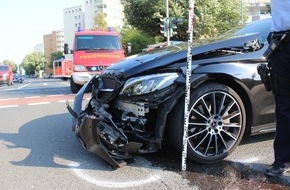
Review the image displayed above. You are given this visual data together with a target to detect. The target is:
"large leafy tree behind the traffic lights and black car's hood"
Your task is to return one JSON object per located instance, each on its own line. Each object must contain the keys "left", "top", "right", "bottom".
{"left": 125, "top": 0, "right": 248, "bottom": 40}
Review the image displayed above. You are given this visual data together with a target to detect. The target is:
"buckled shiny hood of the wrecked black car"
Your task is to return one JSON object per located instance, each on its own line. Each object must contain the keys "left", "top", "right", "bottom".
{"left": 103, "top": 33, "right": 262, "bottom": 78}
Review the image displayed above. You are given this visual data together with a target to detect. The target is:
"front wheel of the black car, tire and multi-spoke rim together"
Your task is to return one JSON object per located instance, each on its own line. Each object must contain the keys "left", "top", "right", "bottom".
{"left": 168, "top": 83, "right": 246, "bottom": 163}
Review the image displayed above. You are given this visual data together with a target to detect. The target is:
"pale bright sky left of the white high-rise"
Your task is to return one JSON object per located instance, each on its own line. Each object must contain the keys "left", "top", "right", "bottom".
{"left": 0, "top": 0, "right": 84, "bottom": 64}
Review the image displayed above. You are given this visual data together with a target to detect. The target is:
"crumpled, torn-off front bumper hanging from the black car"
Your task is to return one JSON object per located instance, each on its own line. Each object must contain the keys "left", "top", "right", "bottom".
{"left": 67, "top": 77, "right": 142, "bottom": 169}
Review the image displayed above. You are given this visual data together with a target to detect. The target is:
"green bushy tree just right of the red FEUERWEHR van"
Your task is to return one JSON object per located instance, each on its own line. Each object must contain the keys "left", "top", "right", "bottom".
{"left": 121, "top": 28, "right": 156, "bottom": 55}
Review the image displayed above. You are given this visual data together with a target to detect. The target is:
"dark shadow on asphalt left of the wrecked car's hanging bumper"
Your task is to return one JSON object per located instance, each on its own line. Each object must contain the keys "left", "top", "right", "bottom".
{"left": 0, "top": 114, "right": 113, "bottom": 170}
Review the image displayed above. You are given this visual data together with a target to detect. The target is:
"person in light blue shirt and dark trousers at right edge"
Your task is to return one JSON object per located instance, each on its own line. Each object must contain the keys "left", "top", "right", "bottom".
{"left": 265, "top": 0, "right": 290, "bottom": 176}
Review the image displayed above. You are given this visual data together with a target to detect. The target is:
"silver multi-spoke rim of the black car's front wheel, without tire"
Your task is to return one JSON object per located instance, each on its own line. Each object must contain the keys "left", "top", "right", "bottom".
{"left": 188, "top": 91, "right": 243, "bottom": 159}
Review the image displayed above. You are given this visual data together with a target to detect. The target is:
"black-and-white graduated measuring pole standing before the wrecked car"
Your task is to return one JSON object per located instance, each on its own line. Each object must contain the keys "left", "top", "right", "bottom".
{"left": 181, "top": 0, "right": 194, "bottom": 171}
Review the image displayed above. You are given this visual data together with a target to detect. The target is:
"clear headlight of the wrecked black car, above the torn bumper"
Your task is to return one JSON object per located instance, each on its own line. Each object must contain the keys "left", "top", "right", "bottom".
{"left": 120, "top": 73, "right": 178, "bottom": 95}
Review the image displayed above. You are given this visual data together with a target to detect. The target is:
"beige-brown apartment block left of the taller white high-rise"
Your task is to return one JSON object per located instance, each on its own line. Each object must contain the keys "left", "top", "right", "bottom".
{"left": 43, "top": 29, "right": 64, "bottom": 74}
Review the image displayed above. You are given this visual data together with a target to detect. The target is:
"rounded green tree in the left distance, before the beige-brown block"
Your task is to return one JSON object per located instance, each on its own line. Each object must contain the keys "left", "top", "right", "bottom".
{"left": 21, "top": 52, "right": 47, "bottom": 74}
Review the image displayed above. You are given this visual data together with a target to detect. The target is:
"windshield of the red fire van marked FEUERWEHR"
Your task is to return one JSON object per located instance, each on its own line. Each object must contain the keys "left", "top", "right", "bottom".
{"left": 75, "top": 35, "right": 121, "bottom": 51}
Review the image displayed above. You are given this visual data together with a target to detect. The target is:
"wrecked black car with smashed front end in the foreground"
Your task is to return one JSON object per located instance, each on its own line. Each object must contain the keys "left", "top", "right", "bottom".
{"left": 68, "top": 19, "right": 275, "bottom": 168}
